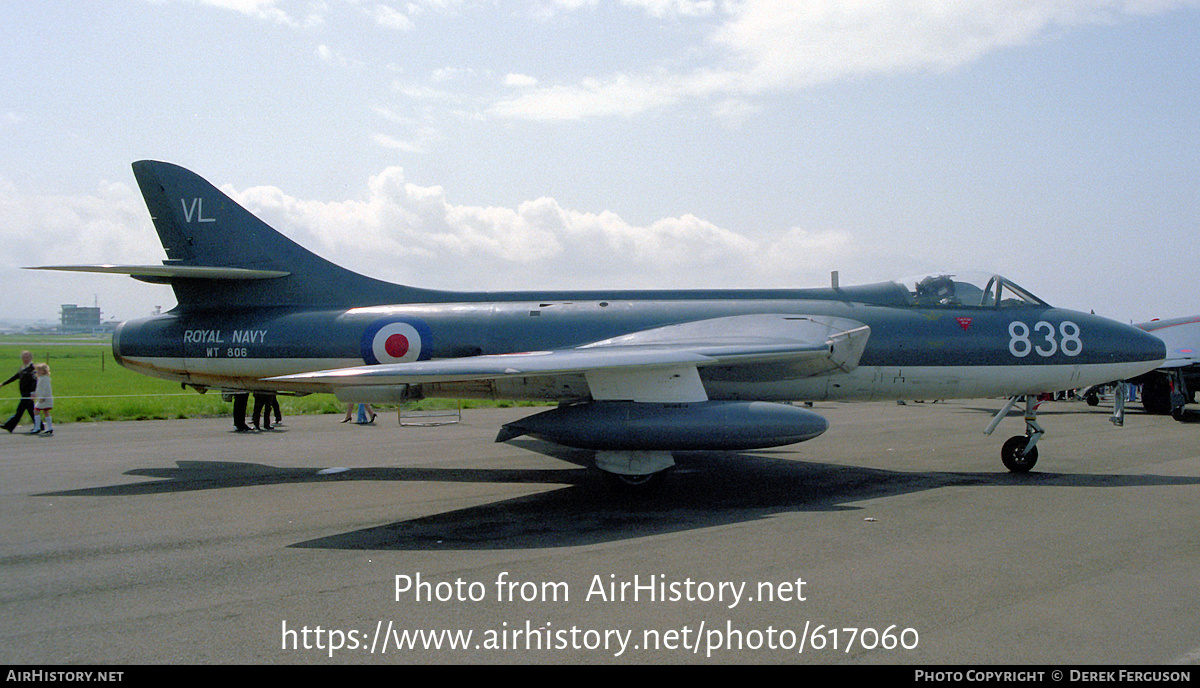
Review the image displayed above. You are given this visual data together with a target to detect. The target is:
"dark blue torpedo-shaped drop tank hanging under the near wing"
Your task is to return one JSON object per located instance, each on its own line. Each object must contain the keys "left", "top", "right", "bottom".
{"left": 496, "top": 401, "right": 829, "bottom": 451}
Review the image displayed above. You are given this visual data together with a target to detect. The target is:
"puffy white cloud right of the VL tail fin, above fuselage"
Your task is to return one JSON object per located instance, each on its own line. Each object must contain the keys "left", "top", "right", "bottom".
{"left": 211, "top": 167, "right": 863, "bottom": 289}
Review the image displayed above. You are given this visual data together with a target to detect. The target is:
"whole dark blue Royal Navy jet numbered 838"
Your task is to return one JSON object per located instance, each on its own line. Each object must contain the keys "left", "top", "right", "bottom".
{"left": 32, "top": 161, "right": 1165, "bottom": 483}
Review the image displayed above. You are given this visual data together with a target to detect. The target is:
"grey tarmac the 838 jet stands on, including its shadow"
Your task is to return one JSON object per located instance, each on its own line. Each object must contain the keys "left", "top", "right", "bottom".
{"left": 0, "top": 400, "right": 1200, "bottom": 664}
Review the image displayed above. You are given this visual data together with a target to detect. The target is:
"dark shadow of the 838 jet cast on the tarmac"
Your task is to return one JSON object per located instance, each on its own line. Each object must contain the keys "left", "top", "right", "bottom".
{"left": 35, "top": 441, "right": 1200, "bottom": 550}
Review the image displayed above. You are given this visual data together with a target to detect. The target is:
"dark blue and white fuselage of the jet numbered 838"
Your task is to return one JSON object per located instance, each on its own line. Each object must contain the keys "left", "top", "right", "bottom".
{"left": 113, "top": 286, "right": 1164, "bottom": 400}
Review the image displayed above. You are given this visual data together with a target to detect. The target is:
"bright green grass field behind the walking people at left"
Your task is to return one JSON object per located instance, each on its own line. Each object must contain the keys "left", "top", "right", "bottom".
{"left": 0, "top": 335, "right": 535, "bottom": 423}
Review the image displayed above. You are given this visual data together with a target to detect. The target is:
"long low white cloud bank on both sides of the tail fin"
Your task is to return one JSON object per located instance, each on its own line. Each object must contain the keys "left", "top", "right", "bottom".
{"left": 0, "top": 167, "right": 916, "bottom": 302}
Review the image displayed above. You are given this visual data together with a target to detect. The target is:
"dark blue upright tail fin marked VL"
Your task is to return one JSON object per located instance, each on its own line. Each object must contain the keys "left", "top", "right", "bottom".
{"left": 127, "top": 160, "right": 421, "bottom": 309}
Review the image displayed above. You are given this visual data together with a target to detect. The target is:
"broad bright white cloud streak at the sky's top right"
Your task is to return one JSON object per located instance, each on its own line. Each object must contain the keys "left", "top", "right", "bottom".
{"left": 490, "top": 0, "right": 1195, "bottom": 120}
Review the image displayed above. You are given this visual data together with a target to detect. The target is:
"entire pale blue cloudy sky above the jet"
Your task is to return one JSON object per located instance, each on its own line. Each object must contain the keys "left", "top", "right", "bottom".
{"left": 0, "top": 0, "right": 1200, "bottom": 322}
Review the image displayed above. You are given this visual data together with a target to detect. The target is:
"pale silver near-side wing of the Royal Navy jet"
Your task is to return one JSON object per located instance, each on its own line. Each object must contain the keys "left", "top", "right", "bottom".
{"left": 269, "top": 315, "right": 871, "bottom": 402}
